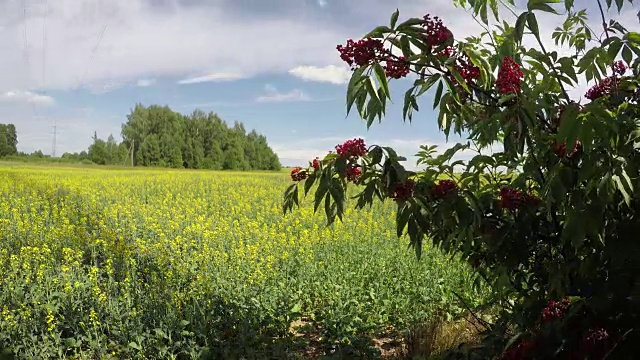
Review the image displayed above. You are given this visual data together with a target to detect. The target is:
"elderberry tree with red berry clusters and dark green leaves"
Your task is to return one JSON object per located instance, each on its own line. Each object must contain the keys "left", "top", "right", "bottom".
{"left": 283, "top": 0, "right": 640, "bottom": 359}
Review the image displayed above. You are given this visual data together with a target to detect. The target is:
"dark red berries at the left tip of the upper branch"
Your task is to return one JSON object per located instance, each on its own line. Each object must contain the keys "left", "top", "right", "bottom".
{"left": 336, "top": 38, "right": 410, "bottom": 79}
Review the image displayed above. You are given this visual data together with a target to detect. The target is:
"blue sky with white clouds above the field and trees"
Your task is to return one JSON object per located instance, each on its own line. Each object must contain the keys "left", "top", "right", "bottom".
{"left": 0, "top": 0, "right": 640, "bottom": 167}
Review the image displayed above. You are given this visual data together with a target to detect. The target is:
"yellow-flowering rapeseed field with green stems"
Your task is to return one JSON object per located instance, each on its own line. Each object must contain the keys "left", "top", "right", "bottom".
{"left": 0, "top": 164, "right": 483, "bottom": 359}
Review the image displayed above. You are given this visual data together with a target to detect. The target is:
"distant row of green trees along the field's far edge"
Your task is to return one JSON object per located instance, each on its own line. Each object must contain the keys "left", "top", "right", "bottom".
{"left": 0, "top": 104, "right": 281, "bottom": 170}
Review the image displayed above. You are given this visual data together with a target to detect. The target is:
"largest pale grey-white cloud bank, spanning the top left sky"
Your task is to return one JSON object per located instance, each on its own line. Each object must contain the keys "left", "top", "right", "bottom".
{"left": 0, "top": 0, "right": 345, "bottom": 92}
